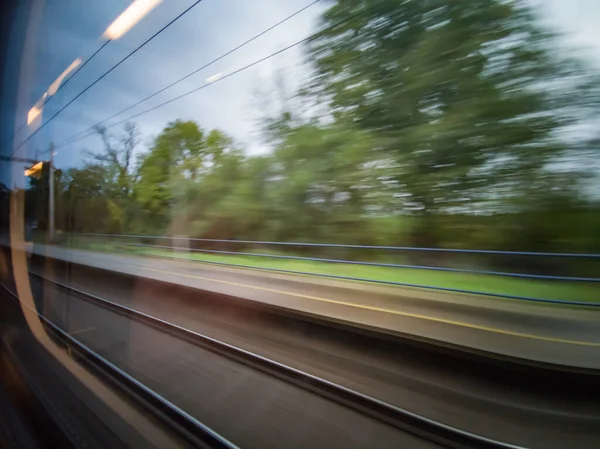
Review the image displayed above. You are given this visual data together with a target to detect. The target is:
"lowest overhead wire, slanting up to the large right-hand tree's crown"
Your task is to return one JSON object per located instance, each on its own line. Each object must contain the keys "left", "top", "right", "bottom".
{"left": 55, "top": 0, "right": 390, "bottom": 148}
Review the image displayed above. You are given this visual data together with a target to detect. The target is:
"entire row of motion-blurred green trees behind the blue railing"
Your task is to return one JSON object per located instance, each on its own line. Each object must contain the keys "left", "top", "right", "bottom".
{"left": 43, "top": 0, "right": 600, "bottom": 265}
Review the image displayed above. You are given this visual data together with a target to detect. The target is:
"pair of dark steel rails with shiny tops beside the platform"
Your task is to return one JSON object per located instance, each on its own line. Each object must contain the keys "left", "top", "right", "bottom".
{"left": 21, "top": 272, "right": 519, "bottom": 448}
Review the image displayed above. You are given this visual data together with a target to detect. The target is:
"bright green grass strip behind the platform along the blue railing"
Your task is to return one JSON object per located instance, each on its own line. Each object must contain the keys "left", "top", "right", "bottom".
{"left": 65, "top": 238, "right": 600, "bottom": 303}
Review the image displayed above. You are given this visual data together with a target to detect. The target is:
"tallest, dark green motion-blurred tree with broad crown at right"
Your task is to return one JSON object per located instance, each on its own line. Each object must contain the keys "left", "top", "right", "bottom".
{"left": 309, "top": 0, "right": 599, "bottom": 245}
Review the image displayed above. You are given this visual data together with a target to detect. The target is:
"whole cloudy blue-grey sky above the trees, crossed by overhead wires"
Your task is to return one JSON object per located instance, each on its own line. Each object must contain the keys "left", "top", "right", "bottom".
{"left": 5, "top": 0, "right": 600, "bottom": 173}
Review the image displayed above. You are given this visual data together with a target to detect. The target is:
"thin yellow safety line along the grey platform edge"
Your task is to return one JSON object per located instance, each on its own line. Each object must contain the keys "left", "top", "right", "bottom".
{"left": 136, "top": 265, "right": 600, "bottom": 347}
